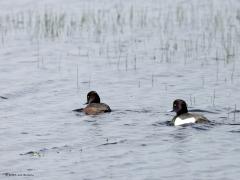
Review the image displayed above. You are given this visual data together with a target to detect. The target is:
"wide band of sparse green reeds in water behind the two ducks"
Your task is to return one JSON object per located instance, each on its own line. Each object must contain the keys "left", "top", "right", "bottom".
{"left": 0, "top": 0, "right": 240, "bottom": 69}
